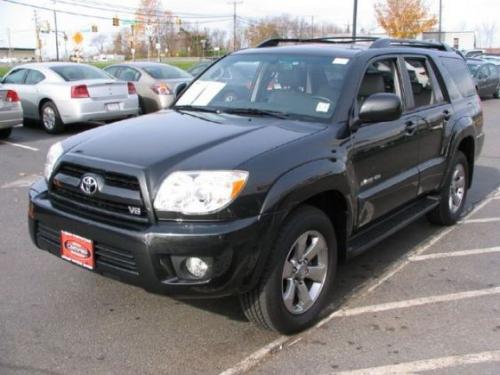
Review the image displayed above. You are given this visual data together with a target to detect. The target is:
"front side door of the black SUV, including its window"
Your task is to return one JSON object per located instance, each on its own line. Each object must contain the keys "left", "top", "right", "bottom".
{"left": 351, "top": 57, "right": 418, "bottom": 227}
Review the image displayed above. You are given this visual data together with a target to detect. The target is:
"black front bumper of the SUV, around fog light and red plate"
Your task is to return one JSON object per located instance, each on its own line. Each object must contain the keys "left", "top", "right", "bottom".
{"left": 29, "top": 184, "right": 272, "bottom": 297}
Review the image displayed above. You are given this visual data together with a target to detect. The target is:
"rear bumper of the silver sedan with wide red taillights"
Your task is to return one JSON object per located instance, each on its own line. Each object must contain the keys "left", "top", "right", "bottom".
{"left": 56, "top": 95, "right": 139, "bottom": 124}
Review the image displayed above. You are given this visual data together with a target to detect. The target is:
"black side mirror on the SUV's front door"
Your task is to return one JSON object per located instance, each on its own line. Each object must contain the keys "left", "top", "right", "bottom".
{"left": 359, "top": 93, "right": 403, "bottom": 123}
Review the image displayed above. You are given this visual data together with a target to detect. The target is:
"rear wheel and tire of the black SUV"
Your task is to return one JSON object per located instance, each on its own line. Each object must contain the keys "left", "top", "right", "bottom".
{"left": 427, "top": 151, "right": 469, "bottom": 225}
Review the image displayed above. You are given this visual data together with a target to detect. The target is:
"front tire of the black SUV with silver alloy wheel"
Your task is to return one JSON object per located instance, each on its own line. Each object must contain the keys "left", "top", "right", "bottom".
{"left": 240, "top": 206, "right": 337, "bottom": 334}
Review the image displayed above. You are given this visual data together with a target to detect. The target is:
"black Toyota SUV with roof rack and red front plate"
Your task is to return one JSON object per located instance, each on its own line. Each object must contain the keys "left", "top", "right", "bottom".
{"left": 29, "top": 38, "right": 484, "bottom": 333}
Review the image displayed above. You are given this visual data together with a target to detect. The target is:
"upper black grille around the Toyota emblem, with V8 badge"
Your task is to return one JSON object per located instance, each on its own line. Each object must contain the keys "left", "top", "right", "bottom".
{"left": 50, "top": 163, "right": 148, "bottom": 223}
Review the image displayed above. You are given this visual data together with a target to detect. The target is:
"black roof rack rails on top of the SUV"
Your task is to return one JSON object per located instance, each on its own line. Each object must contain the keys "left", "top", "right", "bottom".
{"left": 257, "top": 36, "right": 453, "bottom": 51}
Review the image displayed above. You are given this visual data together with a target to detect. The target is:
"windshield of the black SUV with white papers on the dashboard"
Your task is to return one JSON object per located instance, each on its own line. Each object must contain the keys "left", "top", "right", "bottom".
{"left": 176, "top": 53, "right": 349, "bottom": 121}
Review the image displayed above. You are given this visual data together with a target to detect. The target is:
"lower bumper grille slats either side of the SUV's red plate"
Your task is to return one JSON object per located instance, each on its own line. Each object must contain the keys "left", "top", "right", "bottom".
{"left": 36, "top": 223, "right": 139, "bottom": 275}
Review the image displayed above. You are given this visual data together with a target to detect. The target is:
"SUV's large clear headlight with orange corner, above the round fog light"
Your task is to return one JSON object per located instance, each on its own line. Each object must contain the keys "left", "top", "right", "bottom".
{"left": 154, "top": 171, "right": 248, "bottom": 215}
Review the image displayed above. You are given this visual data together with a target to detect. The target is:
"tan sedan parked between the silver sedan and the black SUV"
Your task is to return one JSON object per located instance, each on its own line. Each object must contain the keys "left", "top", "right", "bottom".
{"left": 104, "top": 62, "right": 193, "bottom": 113}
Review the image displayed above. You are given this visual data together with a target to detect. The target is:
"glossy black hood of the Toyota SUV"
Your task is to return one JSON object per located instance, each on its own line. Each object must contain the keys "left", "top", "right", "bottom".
{"left": 63, "top": 110, "right": 327, "bottom": 178}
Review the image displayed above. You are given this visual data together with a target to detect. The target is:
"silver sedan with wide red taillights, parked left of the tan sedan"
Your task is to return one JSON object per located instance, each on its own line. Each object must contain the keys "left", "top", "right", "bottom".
{"left": 2, "top": 62, "right": 139, "bottom": 134}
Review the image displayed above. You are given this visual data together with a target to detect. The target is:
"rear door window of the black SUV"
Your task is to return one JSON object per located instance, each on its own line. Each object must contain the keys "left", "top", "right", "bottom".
{"left": 405, "top": 58, "right": 436, "bottom": 108}
